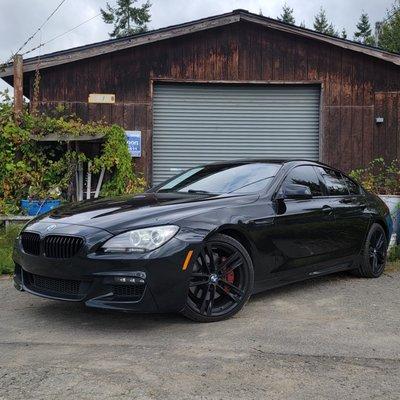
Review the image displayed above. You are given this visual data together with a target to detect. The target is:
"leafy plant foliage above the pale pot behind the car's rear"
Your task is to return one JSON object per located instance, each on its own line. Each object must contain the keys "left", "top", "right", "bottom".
{"left": 350, "top": 158, "right": 400, "bottom": 195}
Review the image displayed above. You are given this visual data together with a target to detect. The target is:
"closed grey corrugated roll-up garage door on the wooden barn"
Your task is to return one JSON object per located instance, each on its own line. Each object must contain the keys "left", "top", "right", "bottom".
{"left": 153, "top": 84, "right": 320, "bottom": 184}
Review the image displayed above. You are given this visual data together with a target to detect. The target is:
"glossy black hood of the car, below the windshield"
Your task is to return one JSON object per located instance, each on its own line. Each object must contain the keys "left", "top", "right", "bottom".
{"left": 28, "top": 193, "right": 259, "bottom": 234}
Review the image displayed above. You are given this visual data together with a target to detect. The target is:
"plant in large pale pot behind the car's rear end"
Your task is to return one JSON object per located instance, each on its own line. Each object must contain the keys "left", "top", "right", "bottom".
{"left": 350, "top": 158, "right": 400, "bottom": 243}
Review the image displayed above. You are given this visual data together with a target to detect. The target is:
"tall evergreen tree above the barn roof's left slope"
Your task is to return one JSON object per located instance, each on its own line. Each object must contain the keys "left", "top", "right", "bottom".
{"left": 100, "top": 0, "right": 151, "bottom": 38}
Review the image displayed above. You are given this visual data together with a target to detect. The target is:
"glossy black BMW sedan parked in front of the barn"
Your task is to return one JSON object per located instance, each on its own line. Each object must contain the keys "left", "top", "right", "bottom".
{"left": 14, "top": 160, "right": 391, "bottom": 322}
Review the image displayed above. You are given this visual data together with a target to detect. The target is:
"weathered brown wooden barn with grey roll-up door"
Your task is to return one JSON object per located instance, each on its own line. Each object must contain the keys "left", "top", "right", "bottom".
{"left": 0, "top": 10, "right": 400, "bottom": 183}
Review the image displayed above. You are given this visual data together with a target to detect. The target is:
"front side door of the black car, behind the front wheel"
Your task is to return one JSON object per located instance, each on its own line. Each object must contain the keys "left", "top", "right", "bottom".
{"left": 268, "top": 165, "right": 336, "bottom": 279}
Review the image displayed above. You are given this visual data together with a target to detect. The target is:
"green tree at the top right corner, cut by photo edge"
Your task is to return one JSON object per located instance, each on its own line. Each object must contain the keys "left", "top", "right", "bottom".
{"left": 378, "top": 0, "right": 400, "bottom": 53}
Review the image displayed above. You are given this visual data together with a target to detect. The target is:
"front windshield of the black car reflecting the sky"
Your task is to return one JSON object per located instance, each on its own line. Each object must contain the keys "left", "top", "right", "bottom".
{"left": 157, "top": 162, "right": 281, "bottom": 194}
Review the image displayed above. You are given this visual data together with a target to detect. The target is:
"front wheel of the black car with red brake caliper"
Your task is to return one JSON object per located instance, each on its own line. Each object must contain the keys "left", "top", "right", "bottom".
{"left": 182, "top": 234, "right": 254, "bottom": 322}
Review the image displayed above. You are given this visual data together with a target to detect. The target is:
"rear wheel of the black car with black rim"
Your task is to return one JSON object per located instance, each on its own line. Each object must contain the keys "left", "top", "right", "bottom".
{"left": 354, "top": 223, "right": 388, "bottom": 278}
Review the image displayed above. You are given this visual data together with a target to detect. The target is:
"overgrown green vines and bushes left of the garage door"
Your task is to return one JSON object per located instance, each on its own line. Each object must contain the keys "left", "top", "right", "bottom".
{"left": 0, "top": 93, "right": 145, "bottom": 214}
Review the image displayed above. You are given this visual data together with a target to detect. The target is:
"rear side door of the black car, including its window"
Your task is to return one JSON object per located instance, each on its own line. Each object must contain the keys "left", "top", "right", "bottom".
{"left": 316, "top": 167, "right": 370, "bottom": 262}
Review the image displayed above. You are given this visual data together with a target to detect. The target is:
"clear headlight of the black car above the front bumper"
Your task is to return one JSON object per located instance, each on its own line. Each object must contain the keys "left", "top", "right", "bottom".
{"left": 102, "top": 225, "right": 179, "bottom": 253}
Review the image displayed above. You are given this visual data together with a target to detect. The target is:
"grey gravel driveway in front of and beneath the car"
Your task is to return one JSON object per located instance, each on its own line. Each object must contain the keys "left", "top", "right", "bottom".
{"left": 0, "top": 271, "right": 400, "bottom": 400}
